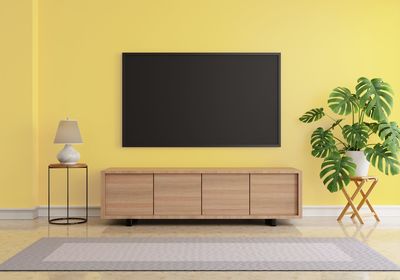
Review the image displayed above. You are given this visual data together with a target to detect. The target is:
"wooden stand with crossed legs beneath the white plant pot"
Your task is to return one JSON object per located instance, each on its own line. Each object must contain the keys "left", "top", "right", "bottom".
{"left": 337, "top": 177, "right": 380, "bottom": 224}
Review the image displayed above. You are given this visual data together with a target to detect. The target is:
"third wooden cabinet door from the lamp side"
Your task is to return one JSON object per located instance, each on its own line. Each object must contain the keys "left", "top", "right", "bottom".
{"left": 202, "top": 174, "right": 249, "bottom": 216}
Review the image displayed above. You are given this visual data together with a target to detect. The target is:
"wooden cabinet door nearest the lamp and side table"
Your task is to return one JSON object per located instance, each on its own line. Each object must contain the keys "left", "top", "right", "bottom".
{"left": 105, "top": 174, "right": 153, "bottom": 218}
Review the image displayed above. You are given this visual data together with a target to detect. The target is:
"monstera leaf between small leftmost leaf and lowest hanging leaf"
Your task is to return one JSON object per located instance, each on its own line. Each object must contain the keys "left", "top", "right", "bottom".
{"left": 311, "top": 127, "right": 337, "bottom": 158}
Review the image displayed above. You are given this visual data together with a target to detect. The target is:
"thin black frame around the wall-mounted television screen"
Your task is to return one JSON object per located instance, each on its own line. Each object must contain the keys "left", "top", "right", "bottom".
{"left": 121, "top": 52, "right": 282, "bottom": 148}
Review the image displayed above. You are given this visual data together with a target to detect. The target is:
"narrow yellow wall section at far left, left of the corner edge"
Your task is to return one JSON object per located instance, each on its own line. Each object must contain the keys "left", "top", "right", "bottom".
{"left": 0, "top": 0, "right": 38, "bottom": 208}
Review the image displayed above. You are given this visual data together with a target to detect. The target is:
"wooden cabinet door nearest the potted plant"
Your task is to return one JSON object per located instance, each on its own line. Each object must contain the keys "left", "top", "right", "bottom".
{"left": 250, "top": 174, "right": 298, "bottom": 216}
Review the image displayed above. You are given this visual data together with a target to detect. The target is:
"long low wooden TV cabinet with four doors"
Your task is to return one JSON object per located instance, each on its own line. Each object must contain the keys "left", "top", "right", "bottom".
{"left": 101, "top": 168, "right": 302, "bottom": 223}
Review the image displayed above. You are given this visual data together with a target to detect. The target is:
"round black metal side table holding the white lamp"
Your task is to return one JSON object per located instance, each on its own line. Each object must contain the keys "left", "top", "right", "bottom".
{"left": 47, "top": 163, "right": 89, "bottom": 225}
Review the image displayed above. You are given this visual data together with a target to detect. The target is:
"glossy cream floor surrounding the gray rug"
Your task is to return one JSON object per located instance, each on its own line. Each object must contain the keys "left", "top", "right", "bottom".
{"left": 0, "top": 217, "right": 400, "bottom": 280}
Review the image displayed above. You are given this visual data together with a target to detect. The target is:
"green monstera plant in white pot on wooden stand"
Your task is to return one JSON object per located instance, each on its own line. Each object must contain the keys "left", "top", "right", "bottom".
{"left": 300, "top": 77, "right": 400, "bottom": 192}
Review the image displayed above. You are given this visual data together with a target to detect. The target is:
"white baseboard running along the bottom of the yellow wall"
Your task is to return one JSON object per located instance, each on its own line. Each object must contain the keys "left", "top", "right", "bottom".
{"left": 0, "top": 205, "right": 400, "bottom": 220}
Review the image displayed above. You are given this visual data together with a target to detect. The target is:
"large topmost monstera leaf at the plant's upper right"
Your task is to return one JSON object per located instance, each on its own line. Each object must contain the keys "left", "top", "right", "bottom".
{"left": 356, "top": 77, "right": 393, "bottom": 121}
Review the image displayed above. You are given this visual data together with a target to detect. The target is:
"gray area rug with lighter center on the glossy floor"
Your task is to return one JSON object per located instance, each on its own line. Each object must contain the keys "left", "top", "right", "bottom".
{"left": 0, "top": 237, "right": 400, "bottom": 271}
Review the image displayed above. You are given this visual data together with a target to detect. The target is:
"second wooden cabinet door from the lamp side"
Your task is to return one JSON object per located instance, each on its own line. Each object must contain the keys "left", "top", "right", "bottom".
{"left": 154, "top": 174, "right": 201, "bottom": 216}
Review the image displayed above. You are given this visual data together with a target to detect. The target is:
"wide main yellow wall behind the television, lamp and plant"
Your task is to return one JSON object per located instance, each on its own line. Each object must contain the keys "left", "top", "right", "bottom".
{"left": 0, "top": 0, "right": 400, "bottom": 209}
